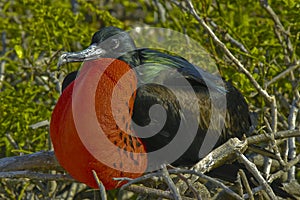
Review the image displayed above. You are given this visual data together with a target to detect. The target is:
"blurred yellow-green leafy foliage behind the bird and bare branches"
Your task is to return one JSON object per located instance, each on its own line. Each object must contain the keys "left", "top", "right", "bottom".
{"left": 0, "top": 0, "right": 300, "bottom": 199}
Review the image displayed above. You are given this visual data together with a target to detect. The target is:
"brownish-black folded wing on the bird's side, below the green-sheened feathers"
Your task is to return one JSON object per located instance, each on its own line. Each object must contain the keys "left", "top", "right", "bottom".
{"left": 132, "top": 84, "right": 229, "bottom": 166}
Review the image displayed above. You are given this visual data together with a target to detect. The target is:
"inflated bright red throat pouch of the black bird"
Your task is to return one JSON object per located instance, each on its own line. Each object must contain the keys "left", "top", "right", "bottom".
{"left": 50, "top": 58, "right": 147, "bottom": 190}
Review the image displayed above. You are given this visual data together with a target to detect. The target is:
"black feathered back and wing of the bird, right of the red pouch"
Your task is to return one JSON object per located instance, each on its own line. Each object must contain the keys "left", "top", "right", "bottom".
{"left": 127, "top": 49, "right": 251, "bottom": 166}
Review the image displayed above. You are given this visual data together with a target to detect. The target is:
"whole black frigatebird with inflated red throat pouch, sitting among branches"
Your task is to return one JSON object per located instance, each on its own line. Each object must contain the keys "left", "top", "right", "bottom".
{"left": 50, "top": 27, "right": 251, "bottom": 189}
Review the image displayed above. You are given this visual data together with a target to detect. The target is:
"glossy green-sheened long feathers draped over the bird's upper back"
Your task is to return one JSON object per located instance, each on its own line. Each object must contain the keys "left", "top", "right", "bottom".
{"left": 135, "top": 49, "right": 226, "bottom": 95}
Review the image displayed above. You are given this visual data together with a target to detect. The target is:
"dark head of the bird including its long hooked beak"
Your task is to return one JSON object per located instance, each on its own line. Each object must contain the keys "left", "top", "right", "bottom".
{"left": 58, "top": 26, "right": 136, "bottom": 66}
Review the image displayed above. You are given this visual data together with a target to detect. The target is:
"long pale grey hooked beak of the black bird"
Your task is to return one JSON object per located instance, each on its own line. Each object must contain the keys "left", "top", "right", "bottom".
{"left": 57, "top": 44, "right": 106, "bottom": 69}
